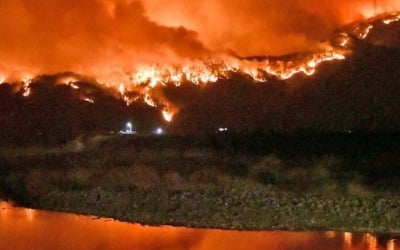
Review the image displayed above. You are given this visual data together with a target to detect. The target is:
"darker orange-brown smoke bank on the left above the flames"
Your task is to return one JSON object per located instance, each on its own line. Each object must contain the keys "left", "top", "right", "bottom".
{"left": 0, "top": 0, "right": 208, "bottom": 77}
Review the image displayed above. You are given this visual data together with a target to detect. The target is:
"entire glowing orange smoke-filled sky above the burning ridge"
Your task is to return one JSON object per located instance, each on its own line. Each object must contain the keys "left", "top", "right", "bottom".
{"left": 0, "top": 0, "right": 400, "bottom": 76}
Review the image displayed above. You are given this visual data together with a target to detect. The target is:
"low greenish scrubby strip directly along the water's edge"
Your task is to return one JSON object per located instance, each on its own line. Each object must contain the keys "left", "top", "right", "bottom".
{"left": 1, "top": 183, "right": 400, "bottom": 234}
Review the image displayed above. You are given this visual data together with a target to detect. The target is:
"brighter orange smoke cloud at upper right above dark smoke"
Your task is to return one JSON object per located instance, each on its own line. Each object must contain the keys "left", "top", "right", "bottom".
{"left": 144, "top": 0, "right": 400, "bottom": 56}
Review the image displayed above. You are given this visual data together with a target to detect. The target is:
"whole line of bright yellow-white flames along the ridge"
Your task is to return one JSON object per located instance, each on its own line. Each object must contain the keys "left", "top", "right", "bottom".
{"left": 0, "top": 13, "right": 400, "bottom": 122}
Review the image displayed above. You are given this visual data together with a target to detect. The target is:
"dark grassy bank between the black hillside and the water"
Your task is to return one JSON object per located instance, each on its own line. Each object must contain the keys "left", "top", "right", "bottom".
{"left": 0, "top": 135, "right": 400, "bottom": 233}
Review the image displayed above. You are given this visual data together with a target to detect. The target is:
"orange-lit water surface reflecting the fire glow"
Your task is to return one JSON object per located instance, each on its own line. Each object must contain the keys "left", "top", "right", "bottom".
{"left": 0, "top": 201, "right": 400, "bottom": 250}
